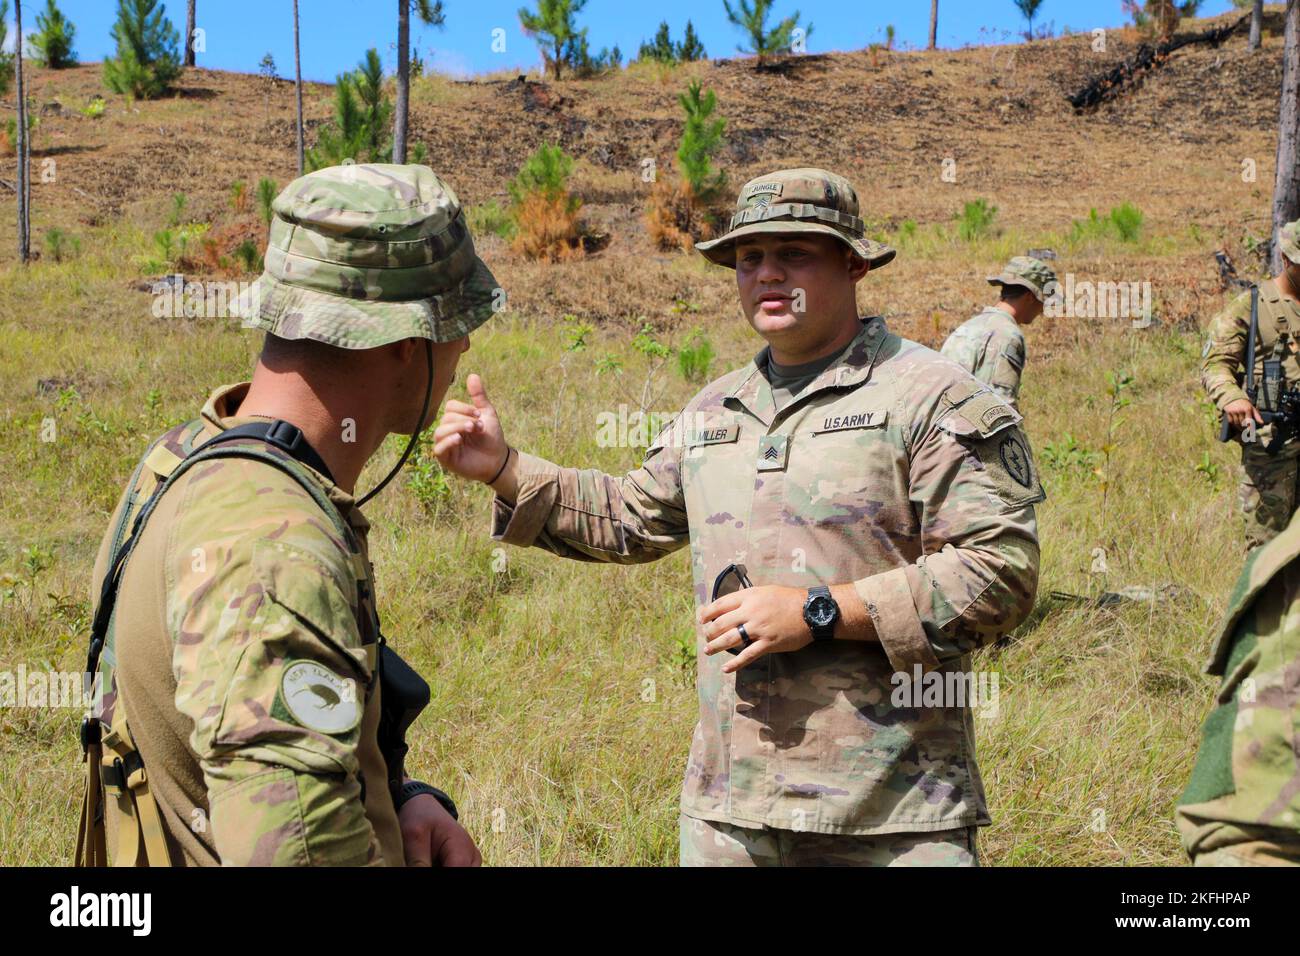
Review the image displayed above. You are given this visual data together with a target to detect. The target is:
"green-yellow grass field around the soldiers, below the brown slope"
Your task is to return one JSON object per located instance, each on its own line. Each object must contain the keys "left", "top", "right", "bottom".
{"left": 0, "top": 229, "right": 1240, "bottom": 865}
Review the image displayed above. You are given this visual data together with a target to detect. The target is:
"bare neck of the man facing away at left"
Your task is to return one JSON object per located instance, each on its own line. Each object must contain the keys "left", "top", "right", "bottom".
{"left": 235, "top": 365, "right": 387, "bottom": 494}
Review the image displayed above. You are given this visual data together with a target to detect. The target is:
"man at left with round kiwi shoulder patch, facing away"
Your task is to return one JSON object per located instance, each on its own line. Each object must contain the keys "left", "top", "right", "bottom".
{"left": 78, "top": 164, "right": 499, "bottom": 865}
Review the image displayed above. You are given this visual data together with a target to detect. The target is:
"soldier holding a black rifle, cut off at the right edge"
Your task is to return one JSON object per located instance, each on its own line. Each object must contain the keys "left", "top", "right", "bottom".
{"left": 1201, "top": 215, "right": 1300, "bottom": 550}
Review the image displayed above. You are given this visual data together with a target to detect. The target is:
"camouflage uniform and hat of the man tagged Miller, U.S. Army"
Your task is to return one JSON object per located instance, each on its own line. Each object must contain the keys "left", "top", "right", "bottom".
{"left": 493, "top": 170, "right": 1043, "bottom": 864}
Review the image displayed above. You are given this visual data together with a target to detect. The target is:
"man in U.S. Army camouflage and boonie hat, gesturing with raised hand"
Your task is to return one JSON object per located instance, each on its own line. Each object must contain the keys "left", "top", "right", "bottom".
{"left": 434, "top": 169, "right": 1043, "bottom": 866}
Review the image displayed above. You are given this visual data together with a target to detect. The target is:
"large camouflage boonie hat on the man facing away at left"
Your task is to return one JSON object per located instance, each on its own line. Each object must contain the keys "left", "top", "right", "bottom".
{"left": 241, "top": 163, "right": 498, "bottom": 349}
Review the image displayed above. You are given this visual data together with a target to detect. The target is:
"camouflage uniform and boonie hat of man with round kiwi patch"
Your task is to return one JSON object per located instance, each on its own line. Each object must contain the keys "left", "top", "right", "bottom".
{"left": 81, "top": 165, "right": 497, "bottom": 865}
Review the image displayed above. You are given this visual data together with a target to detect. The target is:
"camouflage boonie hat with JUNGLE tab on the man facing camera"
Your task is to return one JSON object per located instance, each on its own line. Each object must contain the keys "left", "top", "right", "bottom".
{"left": 696, "top": 169, "right": 897, "bottom": 269}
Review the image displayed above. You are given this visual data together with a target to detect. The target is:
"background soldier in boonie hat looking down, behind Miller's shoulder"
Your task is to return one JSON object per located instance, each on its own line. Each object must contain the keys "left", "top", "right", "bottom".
{"left": 940, "top": 256, "right": 1057, "bottom": 406}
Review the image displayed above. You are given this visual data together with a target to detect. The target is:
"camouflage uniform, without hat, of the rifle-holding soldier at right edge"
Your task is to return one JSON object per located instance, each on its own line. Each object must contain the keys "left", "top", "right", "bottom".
{"left": 1201, "top": 267, "right": 1300, "bottom": 549}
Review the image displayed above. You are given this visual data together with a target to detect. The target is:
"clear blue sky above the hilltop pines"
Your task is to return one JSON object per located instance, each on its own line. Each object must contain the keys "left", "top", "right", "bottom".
{"left": 9, "top": 0, "right": 1231, "bottom": 82}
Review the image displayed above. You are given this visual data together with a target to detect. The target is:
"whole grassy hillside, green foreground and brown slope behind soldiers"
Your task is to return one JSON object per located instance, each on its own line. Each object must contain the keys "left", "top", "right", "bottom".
{"left": 0, "top": 13, "right": 1281, "bottom": 865}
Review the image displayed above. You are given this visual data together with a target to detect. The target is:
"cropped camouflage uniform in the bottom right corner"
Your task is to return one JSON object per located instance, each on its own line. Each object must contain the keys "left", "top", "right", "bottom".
{"left": 1178, "top": 509, "right": 1300, "bottom": 866}
